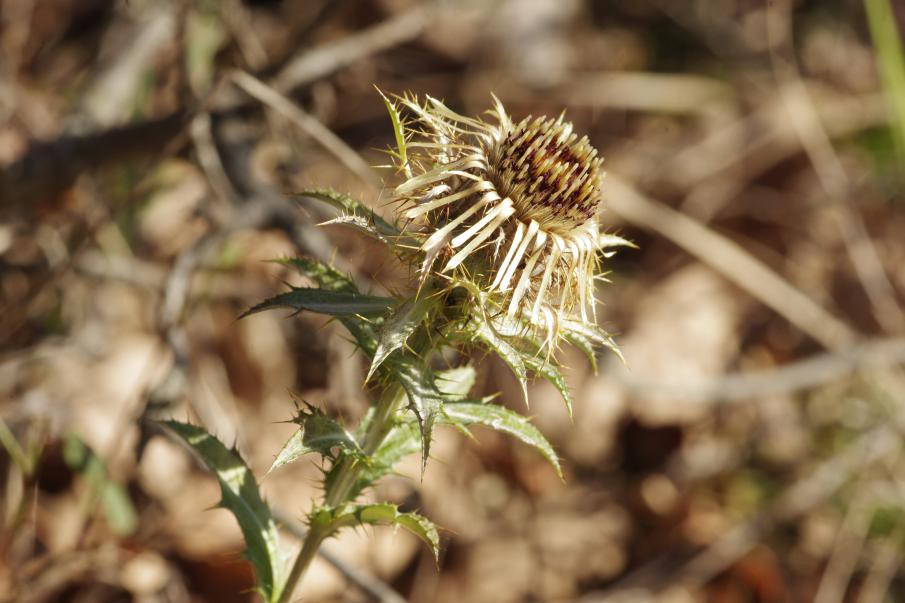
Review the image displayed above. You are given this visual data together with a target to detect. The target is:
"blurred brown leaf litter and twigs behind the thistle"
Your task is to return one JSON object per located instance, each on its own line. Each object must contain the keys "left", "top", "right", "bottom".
{"left": 0, "top": 0, "right": 905, "bottom": 603}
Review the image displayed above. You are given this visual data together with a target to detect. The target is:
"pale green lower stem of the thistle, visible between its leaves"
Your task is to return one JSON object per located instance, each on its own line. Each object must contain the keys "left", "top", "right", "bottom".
{"left": 280, "top": 384, "right": 406, "bottom": 603}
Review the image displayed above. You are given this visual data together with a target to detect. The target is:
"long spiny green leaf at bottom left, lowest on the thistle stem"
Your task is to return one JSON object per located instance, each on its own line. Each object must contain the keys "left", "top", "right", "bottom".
{"left": 161, "top": 421, "right": 286, "bottom": 603}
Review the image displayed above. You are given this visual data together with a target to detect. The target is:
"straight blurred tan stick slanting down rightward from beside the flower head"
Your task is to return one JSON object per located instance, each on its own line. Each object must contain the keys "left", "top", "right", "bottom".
{"left": 606, "top": 175, "right": 856, "bottom": 350}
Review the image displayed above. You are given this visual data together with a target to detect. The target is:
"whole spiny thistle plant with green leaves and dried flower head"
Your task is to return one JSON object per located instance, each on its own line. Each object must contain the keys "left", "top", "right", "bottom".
{"left": 166, "top": 96, "right": 628, "bottom": 602}
